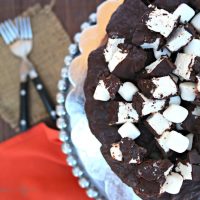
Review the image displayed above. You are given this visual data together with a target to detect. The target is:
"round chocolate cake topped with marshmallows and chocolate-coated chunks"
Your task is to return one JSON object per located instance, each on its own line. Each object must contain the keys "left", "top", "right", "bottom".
{"left": 84, "top": 0, "right": 200, "bottom": 200}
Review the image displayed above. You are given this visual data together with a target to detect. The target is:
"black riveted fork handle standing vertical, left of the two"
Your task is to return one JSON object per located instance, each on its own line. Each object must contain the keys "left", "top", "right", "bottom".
{"left": 19, "top": 80, "right": 29, "bottom": 131}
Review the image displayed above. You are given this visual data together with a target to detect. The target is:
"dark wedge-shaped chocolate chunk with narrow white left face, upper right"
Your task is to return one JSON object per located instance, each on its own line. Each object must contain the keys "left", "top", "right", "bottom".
{"left": 141, "top": 57, "right": 176, "bottom": 78}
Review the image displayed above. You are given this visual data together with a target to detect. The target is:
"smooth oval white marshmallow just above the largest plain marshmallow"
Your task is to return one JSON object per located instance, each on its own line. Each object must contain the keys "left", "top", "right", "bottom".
{"left": 163, "top": 104, "right": 188, "bottom": 123}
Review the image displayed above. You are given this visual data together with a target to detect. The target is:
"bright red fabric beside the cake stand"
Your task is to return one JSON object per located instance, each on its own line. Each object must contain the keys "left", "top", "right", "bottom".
{"left": 0, "top": 123, "right": 89, "bottom": 200}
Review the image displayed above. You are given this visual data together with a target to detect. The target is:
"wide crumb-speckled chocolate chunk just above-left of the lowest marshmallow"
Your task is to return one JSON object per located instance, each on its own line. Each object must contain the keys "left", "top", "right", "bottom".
{"left": 137, "top": 160, "right": 173, "bottom": 181}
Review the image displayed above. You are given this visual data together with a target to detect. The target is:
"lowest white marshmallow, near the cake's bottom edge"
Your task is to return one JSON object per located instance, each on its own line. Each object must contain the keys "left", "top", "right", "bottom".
{"left": 161, "top": 172, "right": 183, "bottom": 194}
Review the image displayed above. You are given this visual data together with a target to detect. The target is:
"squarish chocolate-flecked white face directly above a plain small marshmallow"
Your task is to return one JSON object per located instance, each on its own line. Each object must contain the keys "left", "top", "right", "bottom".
{"left": 116, "top": 102, "right": 139, "bottom": 124}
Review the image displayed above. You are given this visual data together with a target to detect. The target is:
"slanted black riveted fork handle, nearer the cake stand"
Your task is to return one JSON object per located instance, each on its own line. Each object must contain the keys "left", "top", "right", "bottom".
{"left": 32, "top": 76, "right": 56, "bottom": 121}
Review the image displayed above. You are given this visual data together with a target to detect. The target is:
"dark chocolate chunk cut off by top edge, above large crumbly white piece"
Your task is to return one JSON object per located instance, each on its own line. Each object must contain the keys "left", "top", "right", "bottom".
{"left": 153, "top": 0, "right": 189, "bottom": 12}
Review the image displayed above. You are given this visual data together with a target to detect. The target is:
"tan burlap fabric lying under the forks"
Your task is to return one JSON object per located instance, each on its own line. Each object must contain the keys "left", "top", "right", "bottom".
{"left": 0, "top": 4, "right": 70, "bottom": 131}
